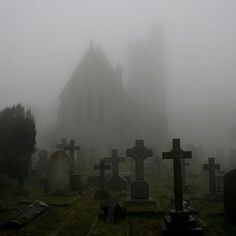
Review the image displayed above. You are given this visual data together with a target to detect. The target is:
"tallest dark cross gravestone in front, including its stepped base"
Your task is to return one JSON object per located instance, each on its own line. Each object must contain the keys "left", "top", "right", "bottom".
{"left": 161, "top": 139, "right": 203, "bottom": 236}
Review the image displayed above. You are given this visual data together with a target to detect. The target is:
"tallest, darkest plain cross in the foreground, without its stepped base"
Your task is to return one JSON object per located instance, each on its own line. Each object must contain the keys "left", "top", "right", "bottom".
{"left": 162, "top": 139, "right": 192, "bottom": 211}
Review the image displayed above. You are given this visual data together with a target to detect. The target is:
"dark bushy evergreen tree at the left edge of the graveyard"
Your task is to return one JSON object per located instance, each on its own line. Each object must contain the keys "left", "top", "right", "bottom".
{"left": 0, "top": 104, "right": 36, "bottom": 187}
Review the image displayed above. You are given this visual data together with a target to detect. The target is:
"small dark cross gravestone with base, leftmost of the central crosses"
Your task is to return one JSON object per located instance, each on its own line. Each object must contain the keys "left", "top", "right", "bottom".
{"left": 94, "top": 159, "right": 110, "bottom": 200}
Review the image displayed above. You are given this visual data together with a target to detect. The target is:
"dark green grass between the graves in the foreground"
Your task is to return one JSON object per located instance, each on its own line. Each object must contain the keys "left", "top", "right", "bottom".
{"left": 0, "top": 162, "right": 236, "bottom": 236}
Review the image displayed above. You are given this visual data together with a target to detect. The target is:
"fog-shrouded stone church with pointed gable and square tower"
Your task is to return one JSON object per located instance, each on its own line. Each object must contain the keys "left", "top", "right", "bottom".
{"left": 57, "top": 32, "right": 168, "bottom": 156}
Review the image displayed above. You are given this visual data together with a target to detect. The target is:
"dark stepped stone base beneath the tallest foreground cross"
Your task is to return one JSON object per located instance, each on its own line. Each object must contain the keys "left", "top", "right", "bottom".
{"left": 161, "top": 210, "right": 204, "bottom": 236}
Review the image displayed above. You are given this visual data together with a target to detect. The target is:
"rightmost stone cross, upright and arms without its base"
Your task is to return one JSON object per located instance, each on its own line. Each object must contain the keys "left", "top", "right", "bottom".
{"left": 203, "top": 157, "right": 220, "bottom": 195}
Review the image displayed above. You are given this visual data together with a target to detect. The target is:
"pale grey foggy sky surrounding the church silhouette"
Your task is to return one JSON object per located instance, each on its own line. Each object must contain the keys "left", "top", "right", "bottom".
{"left": 0, "top": 0, "right": 236, "bottom": 152}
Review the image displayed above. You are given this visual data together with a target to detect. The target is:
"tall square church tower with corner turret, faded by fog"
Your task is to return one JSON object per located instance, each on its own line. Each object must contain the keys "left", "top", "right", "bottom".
{"left": 128, "top": 26, "right": 168, "bottom": 148}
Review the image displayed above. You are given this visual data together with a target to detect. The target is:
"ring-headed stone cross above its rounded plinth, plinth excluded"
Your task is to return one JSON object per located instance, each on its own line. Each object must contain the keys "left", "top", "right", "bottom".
{"left": 126, "top": 140, "right": 153, "bottom": 180}
